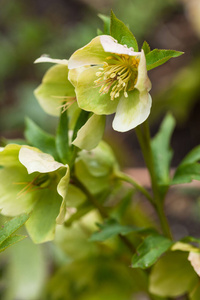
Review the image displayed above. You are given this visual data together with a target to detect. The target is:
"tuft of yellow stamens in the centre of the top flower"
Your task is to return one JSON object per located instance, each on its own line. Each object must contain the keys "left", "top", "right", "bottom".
{"left": 95, "top": 54, "right": 139, "bottom": 100}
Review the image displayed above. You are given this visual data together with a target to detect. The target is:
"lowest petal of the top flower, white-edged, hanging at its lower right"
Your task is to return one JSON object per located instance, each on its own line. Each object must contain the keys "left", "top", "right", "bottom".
{"left": 113, "top": 89, "right": 152, "bottom": 132}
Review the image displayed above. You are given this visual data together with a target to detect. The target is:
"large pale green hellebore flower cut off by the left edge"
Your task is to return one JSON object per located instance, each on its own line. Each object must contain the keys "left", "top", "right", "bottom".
{"left": 0, "top": 144, "right": 69, "bottom": 243}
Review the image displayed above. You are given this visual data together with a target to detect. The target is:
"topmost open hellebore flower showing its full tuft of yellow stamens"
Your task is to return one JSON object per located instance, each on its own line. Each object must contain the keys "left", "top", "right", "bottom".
{"left": 68, "top": 35, "right": 152, "bottom": 132}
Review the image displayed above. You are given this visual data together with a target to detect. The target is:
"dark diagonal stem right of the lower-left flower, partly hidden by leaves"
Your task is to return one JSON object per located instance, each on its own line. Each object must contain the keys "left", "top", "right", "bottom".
{"left": 73, "top": 177, "right": 136, "bottom": 254}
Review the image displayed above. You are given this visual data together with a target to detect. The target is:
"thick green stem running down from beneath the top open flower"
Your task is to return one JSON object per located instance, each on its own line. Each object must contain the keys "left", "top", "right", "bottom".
{"left": 135, "top": 121, "right": 172, "bottom": 239}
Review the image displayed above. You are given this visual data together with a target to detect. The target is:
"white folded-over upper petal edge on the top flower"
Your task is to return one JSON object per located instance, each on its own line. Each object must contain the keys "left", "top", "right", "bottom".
{"left": 100, "top": 35, "right": 141, "bottom": 56}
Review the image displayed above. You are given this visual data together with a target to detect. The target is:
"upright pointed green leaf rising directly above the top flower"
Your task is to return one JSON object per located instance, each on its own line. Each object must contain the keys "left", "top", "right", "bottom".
{"left": 110, "top": 10, "right": 138, "bottom": 52}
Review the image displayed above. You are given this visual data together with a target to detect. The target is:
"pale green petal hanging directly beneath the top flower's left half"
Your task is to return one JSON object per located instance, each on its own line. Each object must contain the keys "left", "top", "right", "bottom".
{"left": 72, "top": 114, "right": 106, "bottom": 150}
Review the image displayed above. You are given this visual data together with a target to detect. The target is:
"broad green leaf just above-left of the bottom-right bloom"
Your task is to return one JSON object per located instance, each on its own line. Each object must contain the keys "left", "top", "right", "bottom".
{"left": 132, "top": 234, "right": 173, "bottom": 269}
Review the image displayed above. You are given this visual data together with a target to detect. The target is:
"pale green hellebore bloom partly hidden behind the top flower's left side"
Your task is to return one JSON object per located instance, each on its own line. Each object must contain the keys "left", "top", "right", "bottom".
{"left": 35, "top": 56, "right": 105, "bottom": 150}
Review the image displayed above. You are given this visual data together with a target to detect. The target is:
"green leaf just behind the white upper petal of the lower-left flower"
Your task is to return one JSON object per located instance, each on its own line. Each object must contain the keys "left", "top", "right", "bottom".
{"left": 24, "top": 118, "right": 58, "bottom": 160}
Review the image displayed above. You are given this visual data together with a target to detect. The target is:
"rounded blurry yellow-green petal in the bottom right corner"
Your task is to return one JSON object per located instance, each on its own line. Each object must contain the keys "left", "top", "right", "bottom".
{"left": 149, "top": 251, "right": 198, "bottom": 297}
